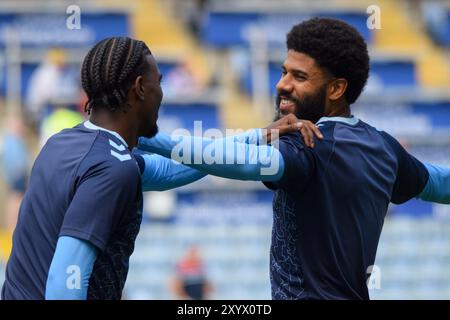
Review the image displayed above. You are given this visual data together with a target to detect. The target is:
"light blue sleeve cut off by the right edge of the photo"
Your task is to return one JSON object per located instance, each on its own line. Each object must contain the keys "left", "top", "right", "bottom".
{"left": 418, "top": 163, "right": 450, "bottom": 204}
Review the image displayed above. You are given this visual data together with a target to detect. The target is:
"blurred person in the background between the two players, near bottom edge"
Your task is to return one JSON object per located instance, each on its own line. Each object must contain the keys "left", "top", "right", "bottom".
{"left": 170, "top": 245, "right": 212, "bottom": 300}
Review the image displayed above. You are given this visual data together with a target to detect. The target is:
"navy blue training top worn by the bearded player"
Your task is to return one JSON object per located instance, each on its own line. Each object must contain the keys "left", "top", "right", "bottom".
{"left": 265, "top": 117, "right": 428, "bottom": 299}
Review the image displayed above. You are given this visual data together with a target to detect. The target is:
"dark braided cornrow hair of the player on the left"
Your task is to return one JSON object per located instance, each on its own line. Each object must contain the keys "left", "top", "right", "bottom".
{"left": 81, "top": 37, "right": 151, "bottom": 114}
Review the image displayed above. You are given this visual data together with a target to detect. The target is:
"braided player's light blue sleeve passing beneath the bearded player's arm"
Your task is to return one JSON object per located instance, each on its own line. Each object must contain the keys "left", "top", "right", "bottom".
{"left": 140, "top": 154, "right": 207, "bottom": 191}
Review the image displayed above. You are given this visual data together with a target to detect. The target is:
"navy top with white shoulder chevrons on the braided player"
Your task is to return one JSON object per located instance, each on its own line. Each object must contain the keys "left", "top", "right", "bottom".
{"left": 2, "top": 122, "right": 142, "bottom": 299}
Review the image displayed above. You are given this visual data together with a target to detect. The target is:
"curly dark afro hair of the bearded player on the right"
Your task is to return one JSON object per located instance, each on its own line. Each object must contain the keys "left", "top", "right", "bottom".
{"left": 287, "top": 18, "right": 370, "bottom": 104}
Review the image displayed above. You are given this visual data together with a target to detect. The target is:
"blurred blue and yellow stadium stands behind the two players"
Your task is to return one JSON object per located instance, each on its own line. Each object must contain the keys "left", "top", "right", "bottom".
{"left": 0, "top": 0, "right": 450, "bottom": 299}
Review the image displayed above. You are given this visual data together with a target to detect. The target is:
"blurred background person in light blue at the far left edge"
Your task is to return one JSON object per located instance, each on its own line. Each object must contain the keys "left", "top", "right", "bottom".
{"left": 0, "top": 115, "right": 30, "bottom": 234}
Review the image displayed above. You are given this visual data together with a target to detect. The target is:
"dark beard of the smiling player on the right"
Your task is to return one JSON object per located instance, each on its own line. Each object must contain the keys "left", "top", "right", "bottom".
{"left": 274, "top": 85, "right": 326, "bottom": 123}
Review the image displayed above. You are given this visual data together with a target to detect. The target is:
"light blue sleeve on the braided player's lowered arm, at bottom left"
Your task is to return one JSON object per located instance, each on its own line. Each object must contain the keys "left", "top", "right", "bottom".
{"left": 45, "top": 236, "right": 97, "bottom": 300}
